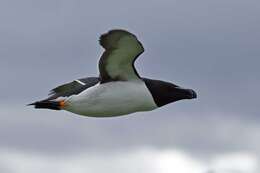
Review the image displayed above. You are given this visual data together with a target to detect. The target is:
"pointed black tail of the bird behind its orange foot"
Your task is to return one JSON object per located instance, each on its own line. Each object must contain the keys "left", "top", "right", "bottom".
{"left": 27, "top": 100, "right": 61, "bottom": 110}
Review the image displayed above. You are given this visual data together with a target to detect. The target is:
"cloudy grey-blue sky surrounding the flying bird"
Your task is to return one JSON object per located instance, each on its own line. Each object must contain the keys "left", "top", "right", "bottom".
{"left": 0, "top": 0, "right": 260, "bottom": 173}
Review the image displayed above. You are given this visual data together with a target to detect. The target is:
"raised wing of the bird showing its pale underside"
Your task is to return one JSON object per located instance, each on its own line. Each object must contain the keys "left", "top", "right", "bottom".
{"left": 99, "top": 30, "right": 144, "bottom": 83}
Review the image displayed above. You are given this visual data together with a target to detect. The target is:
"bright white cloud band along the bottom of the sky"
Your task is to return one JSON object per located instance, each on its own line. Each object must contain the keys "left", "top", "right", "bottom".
{"left": 0, "top": 148, "right": 259, "bottom": 173}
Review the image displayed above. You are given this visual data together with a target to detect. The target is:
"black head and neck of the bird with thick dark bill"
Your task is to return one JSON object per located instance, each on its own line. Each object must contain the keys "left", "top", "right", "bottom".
{"left": 143, "top": 78, "right": 197, "bottom": 107}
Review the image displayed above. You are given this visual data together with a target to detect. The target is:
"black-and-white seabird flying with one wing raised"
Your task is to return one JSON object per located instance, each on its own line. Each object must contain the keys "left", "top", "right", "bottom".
{"left": 28, "top": 29, "right": 197, "bottom": 117}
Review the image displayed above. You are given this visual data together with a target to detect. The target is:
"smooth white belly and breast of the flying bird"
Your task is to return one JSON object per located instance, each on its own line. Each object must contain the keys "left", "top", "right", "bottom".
{"left": 65, "top": 81, "right": 157, "bottom": 117}
